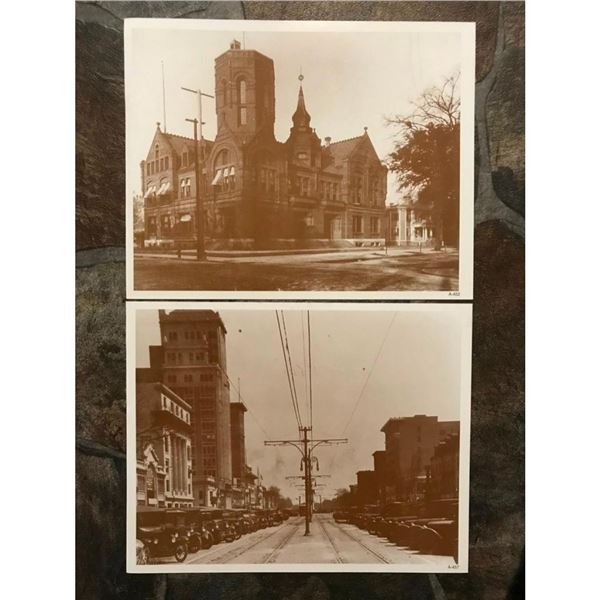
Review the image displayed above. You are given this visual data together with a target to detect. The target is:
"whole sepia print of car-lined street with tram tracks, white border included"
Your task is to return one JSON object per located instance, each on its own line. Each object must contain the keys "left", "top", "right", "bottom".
{"left": 127, "top": 302, "right": 471, "bottom": 573}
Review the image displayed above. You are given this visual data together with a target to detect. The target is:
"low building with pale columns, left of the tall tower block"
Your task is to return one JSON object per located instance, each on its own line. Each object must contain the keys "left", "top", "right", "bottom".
{"left": 136, "top": 378, "right": 193, "bottom": 507}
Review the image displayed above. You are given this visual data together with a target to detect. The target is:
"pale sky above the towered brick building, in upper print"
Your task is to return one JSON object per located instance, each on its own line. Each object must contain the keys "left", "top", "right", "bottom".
{"left": 125, "top": 21, "right": 460, "bottom": 203}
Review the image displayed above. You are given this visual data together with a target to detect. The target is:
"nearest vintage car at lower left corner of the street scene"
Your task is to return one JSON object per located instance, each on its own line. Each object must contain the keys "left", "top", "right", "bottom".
{"left": 136, "top": 507, "right": 188, "bottom": 562}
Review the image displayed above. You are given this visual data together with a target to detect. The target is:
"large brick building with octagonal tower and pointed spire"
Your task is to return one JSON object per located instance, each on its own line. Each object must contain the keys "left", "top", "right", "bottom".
{"left": 140, "top": 41, "right": 387, "bottom": 248}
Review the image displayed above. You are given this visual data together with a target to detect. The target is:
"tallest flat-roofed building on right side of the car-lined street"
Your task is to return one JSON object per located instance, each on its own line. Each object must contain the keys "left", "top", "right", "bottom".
{"left": 381, "top": 415, "right": 460, "bottom": 500}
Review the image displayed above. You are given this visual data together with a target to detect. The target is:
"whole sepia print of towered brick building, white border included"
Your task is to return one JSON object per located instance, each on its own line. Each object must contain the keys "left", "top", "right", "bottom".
{"left": 124, "top": 19, "right": 475, "bottom": 300}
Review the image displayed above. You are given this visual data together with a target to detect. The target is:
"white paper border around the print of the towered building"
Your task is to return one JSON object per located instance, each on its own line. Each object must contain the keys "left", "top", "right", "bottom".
{"left": 124, "top": 19, "right": 475, "bottom": 300}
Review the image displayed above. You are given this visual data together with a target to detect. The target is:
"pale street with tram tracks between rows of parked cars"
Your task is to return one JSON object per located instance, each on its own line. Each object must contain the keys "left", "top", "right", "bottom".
{"left": 161, "top": 514, "right": 455, "bottom": 570}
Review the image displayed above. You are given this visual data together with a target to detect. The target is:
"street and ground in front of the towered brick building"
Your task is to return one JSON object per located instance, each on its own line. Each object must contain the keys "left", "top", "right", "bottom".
{"left": 134, "top": 248, "right": 458, "bottom": 291}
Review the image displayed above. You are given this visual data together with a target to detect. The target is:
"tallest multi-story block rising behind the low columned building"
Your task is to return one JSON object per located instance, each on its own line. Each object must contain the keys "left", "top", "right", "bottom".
{"left": 150, "top": 310, "right": 232, "bottom": 507}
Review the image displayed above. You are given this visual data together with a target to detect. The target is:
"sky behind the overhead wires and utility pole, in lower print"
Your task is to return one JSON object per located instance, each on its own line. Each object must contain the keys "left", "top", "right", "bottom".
{"left": 136, "top": 307, "right": 463, "bottom": 498}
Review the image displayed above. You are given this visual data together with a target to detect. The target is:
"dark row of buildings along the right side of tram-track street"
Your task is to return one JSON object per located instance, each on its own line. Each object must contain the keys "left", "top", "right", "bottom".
{"left": 350, "top": 415, "right": 460, "bottom": 506}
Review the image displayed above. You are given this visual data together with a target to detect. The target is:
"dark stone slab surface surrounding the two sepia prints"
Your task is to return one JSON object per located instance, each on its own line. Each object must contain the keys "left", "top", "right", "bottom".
{"left": 76, "top": 2, "right": 525, "bottom": 600}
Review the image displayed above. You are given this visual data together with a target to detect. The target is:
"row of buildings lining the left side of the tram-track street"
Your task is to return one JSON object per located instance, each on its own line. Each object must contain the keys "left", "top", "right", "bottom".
{"left": 136, "top": 310, "right": 272, "bottom": 508}
